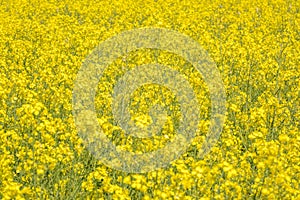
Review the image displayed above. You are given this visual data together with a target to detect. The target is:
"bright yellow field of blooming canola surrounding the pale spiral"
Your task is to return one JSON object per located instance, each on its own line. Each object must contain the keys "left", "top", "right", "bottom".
{"left": 0, "top": 0, "right": 300, "bottom": 200}
